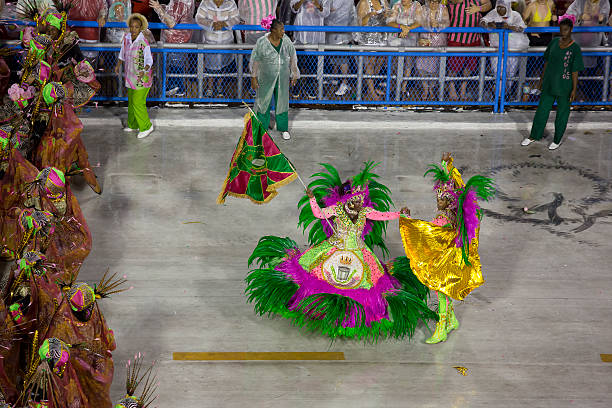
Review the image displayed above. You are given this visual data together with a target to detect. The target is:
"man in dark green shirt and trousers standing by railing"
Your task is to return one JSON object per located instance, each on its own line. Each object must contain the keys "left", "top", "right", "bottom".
{"left": 521, "top": 18, "right": 584, "bottom": 150}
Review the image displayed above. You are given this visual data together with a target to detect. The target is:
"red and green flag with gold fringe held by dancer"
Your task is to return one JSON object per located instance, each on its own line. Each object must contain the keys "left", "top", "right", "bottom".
{"left": 217, "top": 111, "right": 297, "bottom": 204}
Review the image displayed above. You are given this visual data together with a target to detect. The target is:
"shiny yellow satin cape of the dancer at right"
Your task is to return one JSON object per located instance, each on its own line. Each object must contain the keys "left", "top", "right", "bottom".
{"left": 399, "top": 217, "right": 484, "bottom": 300}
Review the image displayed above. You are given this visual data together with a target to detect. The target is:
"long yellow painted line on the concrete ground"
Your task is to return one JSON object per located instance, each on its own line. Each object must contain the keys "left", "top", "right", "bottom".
{"left": 172, "top": 351, "right": 344, "bottom": 361}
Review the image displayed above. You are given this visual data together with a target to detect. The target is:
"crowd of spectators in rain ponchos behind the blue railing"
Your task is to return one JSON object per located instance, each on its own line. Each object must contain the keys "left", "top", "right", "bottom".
{"left": 1, "top": 0, "right": 612, "bottom": 100}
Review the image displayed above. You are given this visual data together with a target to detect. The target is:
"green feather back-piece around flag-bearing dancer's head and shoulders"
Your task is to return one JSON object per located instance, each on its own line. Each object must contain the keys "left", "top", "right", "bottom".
{"left": 298, "top": 161, "right": 393, "bottom": 257}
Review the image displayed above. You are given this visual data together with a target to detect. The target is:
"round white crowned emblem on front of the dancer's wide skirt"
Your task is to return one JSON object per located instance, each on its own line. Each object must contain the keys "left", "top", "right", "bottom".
{"left": 322, "top": 251, "right": 365, "bottom": 289}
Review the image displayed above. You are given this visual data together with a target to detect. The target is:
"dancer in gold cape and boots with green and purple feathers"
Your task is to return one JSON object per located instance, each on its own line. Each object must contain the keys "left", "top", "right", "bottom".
{"left": 400, "top": 153, "right": 495, "bottom": 344}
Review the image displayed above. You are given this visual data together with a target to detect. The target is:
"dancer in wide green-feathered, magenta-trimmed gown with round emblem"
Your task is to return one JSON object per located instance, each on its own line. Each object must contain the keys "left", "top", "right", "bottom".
{"left": 246, "top": 162, "right": 436, "bottom": 341}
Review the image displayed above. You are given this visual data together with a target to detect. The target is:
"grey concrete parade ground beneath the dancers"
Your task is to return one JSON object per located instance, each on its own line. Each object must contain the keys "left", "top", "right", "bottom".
{"left": 49, "top": 108, "right": 612, "bottom": 408}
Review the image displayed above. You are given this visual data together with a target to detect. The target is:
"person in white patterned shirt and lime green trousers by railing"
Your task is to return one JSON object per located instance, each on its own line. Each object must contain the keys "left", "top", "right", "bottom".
{"left": 115, "top": 13, "right": 153, "bottom": 139}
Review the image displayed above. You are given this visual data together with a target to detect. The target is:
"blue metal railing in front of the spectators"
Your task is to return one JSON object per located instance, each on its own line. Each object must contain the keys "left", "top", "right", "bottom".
{"left": 2, "top": 21, "right": 612, "bottom": 112}
